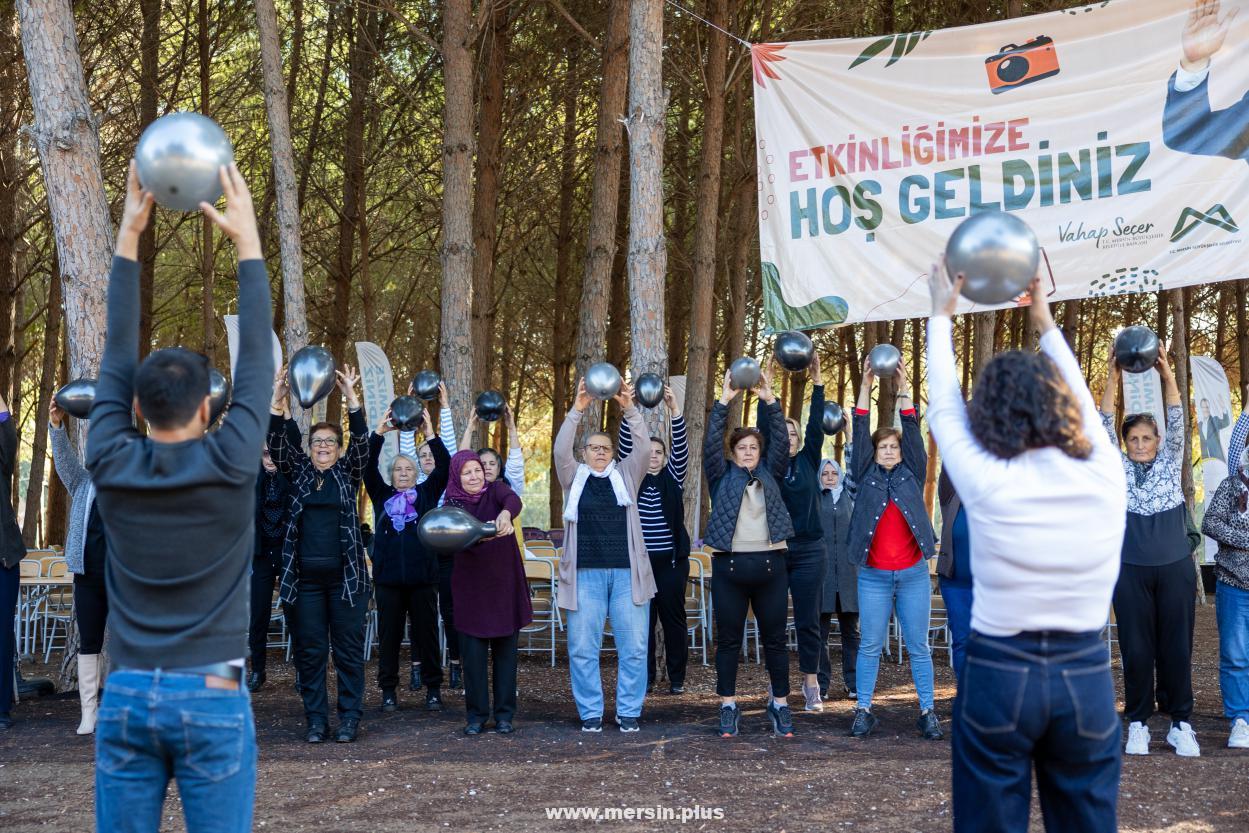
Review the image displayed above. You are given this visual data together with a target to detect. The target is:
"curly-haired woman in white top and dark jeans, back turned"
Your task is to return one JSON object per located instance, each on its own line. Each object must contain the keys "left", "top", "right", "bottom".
{"left": 928, "top": 266, "right": 1128, "bottom": 833}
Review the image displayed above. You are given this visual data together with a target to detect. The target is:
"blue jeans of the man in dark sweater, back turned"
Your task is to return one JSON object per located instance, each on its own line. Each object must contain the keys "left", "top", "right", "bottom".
{"left": 95, "top": 669, "right": 256, "bottom": 833}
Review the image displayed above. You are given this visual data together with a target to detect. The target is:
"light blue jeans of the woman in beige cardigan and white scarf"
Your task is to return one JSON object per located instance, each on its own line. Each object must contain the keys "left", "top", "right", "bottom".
{"left": 568, "top": 567, "right": 651, "bottom": 721}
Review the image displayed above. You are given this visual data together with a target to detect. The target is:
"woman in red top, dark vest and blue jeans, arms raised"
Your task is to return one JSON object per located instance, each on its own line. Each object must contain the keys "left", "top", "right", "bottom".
{"left": 849, "top": 361, "right": 942, "bottom": 741}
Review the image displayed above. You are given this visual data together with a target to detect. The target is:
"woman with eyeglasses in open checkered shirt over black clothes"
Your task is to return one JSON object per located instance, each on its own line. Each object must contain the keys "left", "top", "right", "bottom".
{"left": 269, "top": 365, "right": 368, "bottom": 743}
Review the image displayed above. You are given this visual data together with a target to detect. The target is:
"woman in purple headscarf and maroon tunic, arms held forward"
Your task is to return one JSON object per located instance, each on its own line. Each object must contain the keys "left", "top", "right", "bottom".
{"left": 446, "top": 451, "right": 533, "bottom": 734}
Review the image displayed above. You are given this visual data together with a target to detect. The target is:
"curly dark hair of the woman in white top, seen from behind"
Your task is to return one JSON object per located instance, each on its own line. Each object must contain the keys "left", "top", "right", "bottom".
{"left": 967, "top": 350, "right": 1093, "bottom": 460}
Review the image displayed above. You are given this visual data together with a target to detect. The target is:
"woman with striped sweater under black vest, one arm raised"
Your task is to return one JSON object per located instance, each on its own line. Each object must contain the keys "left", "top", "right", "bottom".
{"left": 617, "top": 385, "right": 689, "bottom": 694}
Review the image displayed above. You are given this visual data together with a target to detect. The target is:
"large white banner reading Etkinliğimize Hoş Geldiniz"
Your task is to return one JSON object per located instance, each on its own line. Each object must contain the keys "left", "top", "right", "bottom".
{"left": 752, "top": 0, "right": 1249, "bottom": 332}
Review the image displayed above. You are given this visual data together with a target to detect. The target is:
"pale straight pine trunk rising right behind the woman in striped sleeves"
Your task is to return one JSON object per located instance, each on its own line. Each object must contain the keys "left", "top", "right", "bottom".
{"left": 628, "top": 0, "right": 668, "bottom": 424}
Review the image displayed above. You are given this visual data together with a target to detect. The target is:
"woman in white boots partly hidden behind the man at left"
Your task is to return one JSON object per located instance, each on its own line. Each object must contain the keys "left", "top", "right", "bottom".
{"left": 47, "top": 402, "right": 109, "bottom": 734}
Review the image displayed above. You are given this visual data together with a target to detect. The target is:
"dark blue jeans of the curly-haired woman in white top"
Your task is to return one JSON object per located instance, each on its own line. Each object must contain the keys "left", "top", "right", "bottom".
{"left": 952, "top": 631, "right": 1122, "bottom": 833}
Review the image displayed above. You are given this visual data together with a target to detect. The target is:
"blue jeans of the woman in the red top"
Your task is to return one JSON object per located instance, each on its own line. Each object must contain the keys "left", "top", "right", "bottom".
{"left": 857, "top": 559, "right": 933, "bottom": 711}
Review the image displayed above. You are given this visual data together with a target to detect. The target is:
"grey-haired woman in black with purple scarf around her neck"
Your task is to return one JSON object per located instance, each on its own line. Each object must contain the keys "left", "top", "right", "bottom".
{"left": 365, "top": 411, "right": 451, "bottom": 712}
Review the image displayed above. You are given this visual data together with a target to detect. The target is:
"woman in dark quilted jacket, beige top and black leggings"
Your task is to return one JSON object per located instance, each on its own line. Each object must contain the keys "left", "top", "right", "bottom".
{"left": 703, "top": 364, "right": 793, "bottom": 738}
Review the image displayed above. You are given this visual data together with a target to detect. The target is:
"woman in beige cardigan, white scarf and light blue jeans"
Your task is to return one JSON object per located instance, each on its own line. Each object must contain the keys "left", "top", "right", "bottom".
{"left": 552, "top": 380, "right": 656, "bottom": 732}
